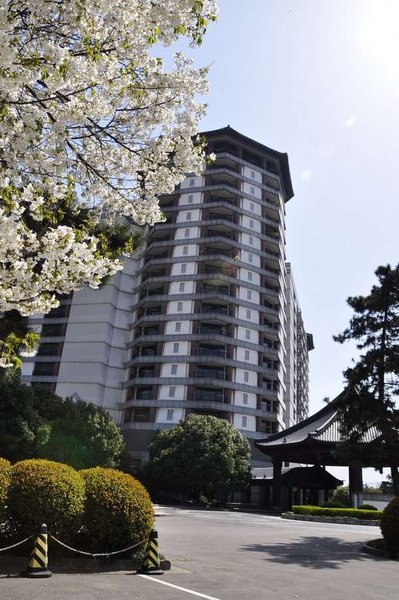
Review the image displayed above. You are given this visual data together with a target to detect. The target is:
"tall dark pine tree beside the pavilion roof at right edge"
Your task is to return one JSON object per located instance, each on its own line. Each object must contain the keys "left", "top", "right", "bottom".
{"left": 334, "top": 265, "right": 399, "bottom": 494}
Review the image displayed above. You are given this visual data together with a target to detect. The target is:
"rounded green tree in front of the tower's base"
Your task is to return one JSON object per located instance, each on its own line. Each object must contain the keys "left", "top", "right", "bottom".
{"left": 144, "top": 414, "right": 251, "bottom": 500}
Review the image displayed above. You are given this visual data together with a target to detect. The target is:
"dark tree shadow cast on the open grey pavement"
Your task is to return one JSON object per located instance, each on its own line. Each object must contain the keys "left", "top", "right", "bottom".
{"left": 240, "top": 537, "right": 382, "bottom": 569}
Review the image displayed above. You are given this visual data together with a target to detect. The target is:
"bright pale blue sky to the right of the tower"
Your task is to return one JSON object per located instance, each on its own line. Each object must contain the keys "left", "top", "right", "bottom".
{"left": 187, "top": 0, "right": 399, "bottom": 483}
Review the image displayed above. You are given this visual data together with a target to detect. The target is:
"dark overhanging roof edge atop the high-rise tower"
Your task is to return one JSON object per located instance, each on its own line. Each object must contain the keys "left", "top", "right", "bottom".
{"left": 200, "top": 125, "right": 294, "bottom": 202}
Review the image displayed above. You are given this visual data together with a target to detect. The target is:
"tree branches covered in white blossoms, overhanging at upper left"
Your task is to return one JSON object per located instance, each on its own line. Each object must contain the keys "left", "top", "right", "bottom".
{"left": 0, "top": 0, "right": 215, "bottom": 367}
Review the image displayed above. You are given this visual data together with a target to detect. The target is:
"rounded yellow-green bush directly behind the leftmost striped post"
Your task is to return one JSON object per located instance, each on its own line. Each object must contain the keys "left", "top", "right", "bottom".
{"left": 8, "top": 459, "right": 84, "bottom": 539}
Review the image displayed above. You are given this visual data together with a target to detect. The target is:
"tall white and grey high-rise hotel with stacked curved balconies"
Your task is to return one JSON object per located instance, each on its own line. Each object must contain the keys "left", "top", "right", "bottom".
{"left": 23, "top": 127, "right": 311, "bottom": 466}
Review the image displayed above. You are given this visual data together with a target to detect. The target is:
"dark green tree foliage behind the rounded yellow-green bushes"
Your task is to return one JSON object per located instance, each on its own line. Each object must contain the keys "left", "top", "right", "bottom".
{"left": 0, "top": 377, "right": 125, "bottom": 469}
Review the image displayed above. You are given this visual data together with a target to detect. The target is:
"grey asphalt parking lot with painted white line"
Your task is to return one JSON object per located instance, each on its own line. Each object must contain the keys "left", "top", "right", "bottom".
{"left": 0, "top": 508, "right": 399, "bottom": 600}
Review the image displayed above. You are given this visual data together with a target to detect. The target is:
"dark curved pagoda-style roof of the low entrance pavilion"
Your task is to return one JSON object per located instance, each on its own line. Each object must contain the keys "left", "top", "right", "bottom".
{"left": 256, "top": 388, "right": 381, "bottom": 466}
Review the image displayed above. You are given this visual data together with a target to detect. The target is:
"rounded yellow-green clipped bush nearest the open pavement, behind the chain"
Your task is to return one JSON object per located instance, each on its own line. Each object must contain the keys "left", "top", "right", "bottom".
{"left": 80, "top": 467, "right": 154, "bottom": 552}
